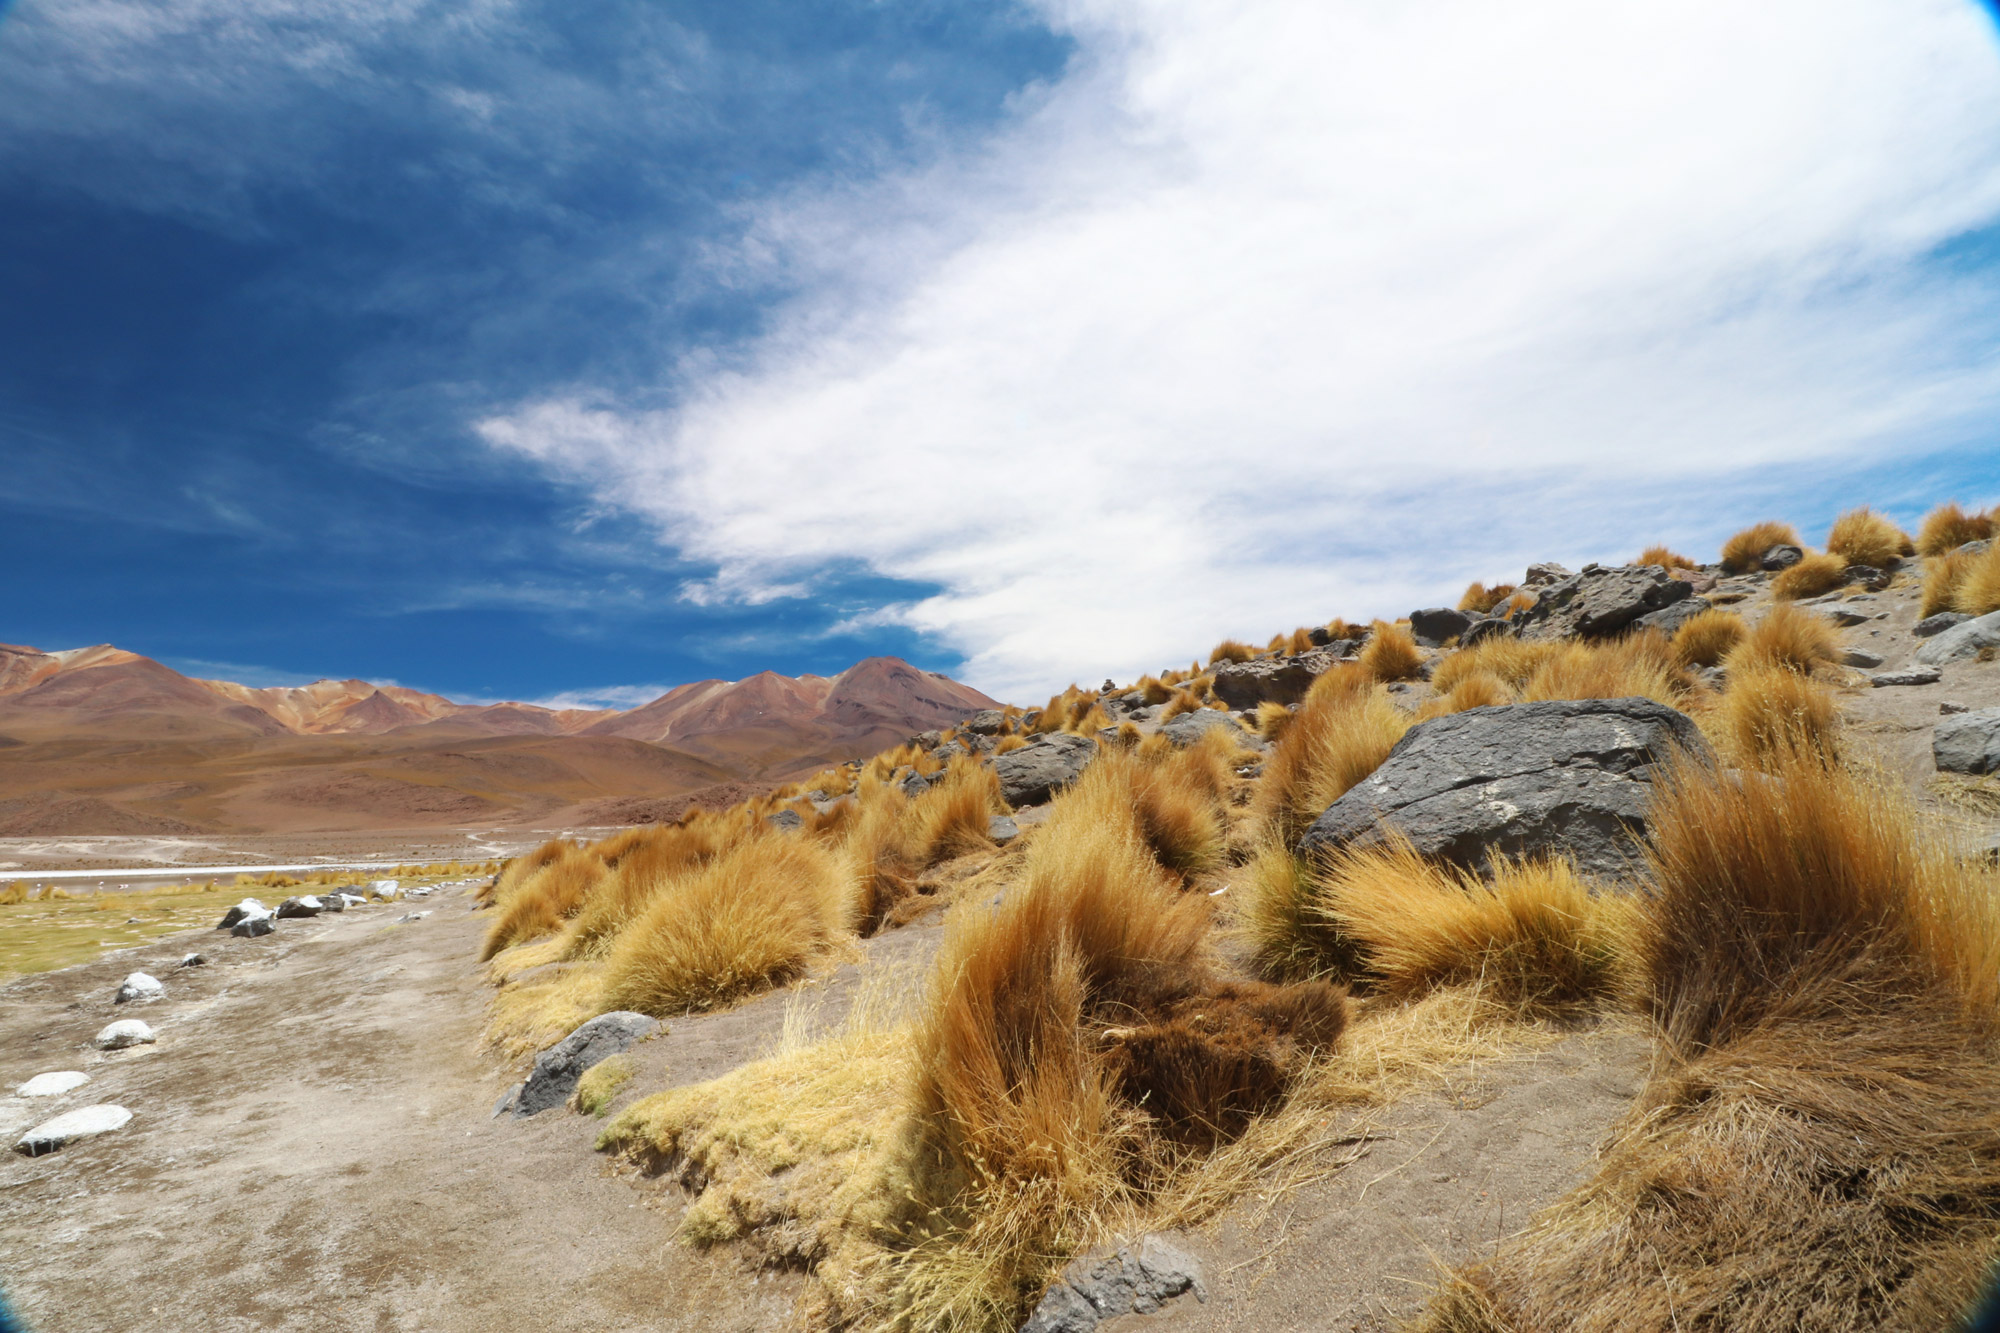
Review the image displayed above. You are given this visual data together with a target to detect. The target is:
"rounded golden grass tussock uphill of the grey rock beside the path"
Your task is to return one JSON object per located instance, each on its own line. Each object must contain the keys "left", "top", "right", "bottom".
{"left": 584, "top": 833, "right": 856, "bottom": 1017}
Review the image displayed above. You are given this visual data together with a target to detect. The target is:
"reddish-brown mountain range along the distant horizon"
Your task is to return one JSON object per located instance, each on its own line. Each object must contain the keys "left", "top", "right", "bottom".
{"left": 0, "top": 644, "right": 994, "bottom": 837}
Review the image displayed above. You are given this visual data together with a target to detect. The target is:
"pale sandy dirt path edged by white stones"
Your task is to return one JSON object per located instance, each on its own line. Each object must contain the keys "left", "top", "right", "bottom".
{"left": 0, "top": 880, "right": 828, "bottom": 1333}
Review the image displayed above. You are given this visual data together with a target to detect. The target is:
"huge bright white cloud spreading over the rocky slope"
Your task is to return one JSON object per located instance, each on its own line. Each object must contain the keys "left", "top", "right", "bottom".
{"left": 480, "top": 0, "right": 2000, "bottom": 697}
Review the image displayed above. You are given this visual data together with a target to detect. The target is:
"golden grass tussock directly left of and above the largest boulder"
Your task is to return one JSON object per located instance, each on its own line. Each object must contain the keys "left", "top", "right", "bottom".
{"left": 1252, "top": 664, "right": 1412, "bottom": 847}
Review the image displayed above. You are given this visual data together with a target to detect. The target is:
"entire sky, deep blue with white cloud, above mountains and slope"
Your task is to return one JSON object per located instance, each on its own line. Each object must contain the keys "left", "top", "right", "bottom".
{"left": 0, "top": 0, "right": 2000, "bottom": 701}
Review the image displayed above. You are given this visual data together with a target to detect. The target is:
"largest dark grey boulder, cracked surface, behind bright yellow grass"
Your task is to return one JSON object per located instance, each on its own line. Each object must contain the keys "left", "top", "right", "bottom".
{"left": 1298, "top": 699, "right": 1710, "bottom": 879}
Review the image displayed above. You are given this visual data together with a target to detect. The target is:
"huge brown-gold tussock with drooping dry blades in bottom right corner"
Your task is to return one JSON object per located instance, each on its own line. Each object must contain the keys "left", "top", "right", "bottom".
{"left": 1416, "top": 755, "right": 2000, "bottom": 1333}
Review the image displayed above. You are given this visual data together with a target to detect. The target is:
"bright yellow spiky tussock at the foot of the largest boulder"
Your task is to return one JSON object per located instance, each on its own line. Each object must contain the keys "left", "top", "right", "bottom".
{"left": 1306, "top": 839, "right": 1638, "bottom": 1015}
